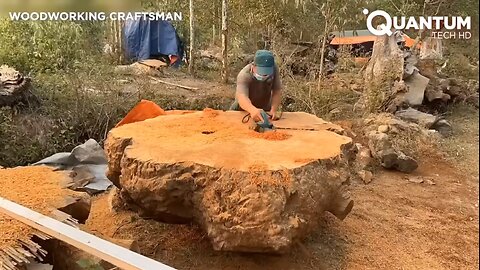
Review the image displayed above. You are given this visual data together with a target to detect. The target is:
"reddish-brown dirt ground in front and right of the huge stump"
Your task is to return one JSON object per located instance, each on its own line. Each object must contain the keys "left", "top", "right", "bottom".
{"left": 84, "top": 105, "right": 479, "bottom": 269}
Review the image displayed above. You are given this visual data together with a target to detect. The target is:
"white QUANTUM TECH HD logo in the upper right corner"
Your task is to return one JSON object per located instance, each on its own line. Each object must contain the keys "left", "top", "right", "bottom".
{"left": 363, "top": 9, "right": 472, "bottom": 38}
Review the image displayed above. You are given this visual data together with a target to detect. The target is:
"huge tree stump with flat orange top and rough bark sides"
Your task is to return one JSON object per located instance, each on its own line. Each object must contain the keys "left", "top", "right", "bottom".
{"left": 105, "top": 110, "right": 353, "bottom": 253}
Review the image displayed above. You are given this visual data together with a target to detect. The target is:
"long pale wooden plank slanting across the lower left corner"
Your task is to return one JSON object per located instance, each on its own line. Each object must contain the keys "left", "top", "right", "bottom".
{"left": 0, "top": 197, "right": 174, "bottom": 270}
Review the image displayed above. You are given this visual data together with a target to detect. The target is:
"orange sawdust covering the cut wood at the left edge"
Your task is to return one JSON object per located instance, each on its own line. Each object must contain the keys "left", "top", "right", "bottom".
{"left": 0, "top": 166, "right": 74, "bottom": 249}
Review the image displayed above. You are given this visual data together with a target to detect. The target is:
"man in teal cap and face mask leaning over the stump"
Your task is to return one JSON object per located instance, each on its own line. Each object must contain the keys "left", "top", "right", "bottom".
{"left": 230, "top": 50, "right": 282, "bottom": 122}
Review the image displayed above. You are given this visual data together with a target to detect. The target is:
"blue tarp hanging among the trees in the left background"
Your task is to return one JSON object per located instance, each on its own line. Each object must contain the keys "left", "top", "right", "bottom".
{"left": 123, "top": 20, "right": 184, "bottom": 66}
